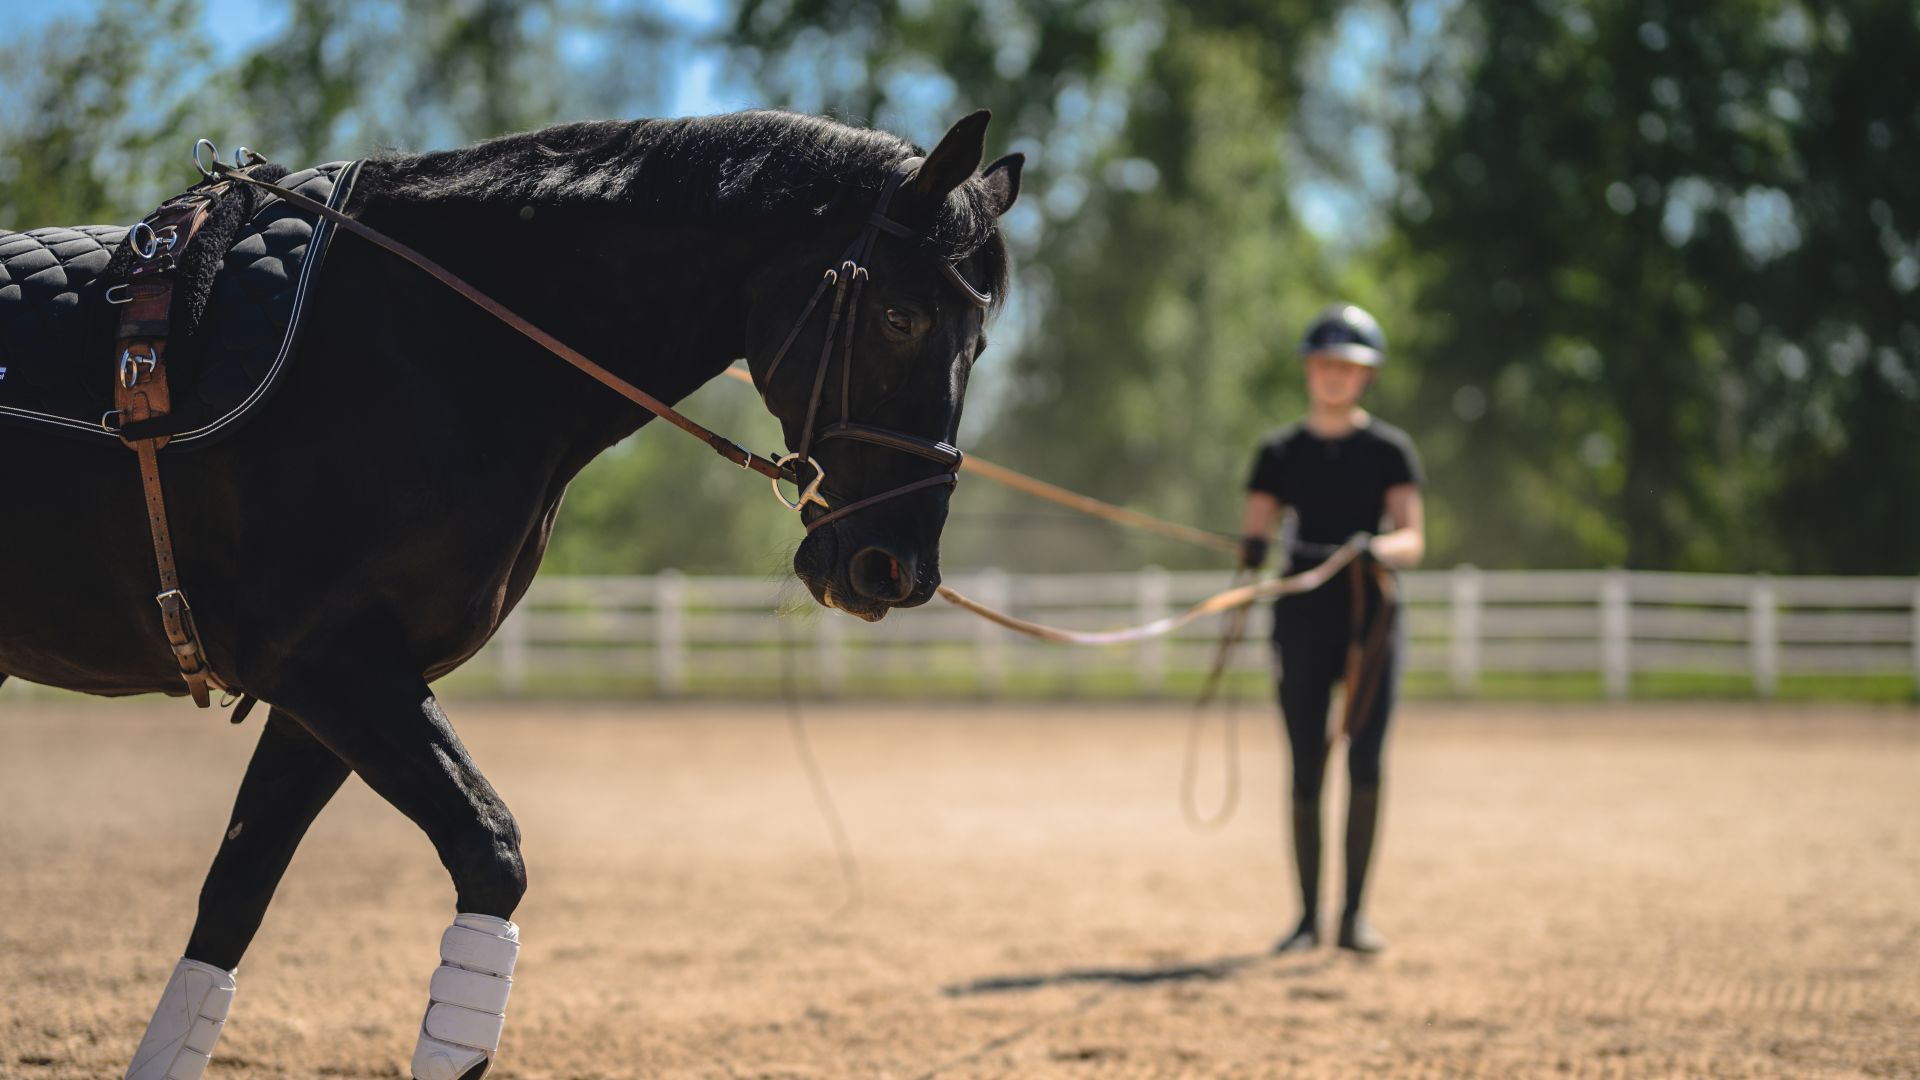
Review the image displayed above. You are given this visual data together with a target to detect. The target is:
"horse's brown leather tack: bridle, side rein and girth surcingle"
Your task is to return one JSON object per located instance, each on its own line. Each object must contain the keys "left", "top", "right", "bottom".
{"left": 120, "top": 138, "right": 993, "bottom": 707}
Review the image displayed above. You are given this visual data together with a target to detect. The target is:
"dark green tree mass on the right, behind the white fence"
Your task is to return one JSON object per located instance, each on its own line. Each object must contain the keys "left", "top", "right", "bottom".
{"left": 1398, "top": 0, "right": 1920, "bottom": 573}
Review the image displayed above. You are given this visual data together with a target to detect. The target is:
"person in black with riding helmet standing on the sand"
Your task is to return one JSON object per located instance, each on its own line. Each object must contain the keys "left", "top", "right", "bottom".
{"left": 1240, "top": 304, "right": 1427, "bottom": 953}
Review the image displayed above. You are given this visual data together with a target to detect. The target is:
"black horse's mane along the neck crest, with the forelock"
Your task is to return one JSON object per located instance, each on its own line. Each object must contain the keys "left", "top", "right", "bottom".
{"left": 363, "top": 110, "right": 1008, "bottom": 307}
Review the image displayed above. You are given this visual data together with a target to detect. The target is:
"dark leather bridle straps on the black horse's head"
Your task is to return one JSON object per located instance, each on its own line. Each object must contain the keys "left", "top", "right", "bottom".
{"left": 762, "top": 158, "right": 993, "bottom": 532}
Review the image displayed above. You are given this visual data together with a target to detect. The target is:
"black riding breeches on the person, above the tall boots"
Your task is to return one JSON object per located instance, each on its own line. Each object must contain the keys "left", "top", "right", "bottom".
{"left": 1273, "top": 632, "right": 1404, "bottom": 801}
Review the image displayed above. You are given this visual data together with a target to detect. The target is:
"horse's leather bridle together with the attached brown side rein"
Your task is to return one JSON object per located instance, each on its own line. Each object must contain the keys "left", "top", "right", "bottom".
{"left": 194, "top": 148, "right": 993, "bottom": 532}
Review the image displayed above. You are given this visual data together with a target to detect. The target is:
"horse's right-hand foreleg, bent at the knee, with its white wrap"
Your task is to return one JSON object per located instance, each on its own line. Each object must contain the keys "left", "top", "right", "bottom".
{"left": 276, "top": 671, "right": 526, "bottom": 1080}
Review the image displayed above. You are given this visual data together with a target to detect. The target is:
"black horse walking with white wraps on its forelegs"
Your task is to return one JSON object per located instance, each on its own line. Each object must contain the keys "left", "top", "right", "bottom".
{"left": 0, "top": 111, "right": 1021, "bottom": 1080}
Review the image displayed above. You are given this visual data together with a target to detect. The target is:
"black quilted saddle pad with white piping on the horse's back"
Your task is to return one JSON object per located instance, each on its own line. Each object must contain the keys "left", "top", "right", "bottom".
{"left": 0, "top": 161, "right": 359, "bottom": 448}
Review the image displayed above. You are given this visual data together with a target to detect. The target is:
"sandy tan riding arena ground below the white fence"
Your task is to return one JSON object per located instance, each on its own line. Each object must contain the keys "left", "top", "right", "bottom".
{"left": 0, "top": 690, "right": 1920, "bottom": 1080}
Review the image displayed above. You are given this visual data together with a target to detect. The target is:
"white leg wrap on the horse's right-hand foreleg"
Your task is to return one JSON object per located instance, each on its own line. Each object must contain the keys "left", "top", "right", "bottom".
{"left": 413, "top": 915, "right": 520, "bottom": 1080}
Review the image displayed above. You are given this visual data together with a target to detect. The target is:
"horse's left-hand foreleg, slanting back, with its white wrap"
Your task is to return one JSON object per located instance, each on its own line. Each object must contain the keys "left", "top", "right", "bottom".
{"left": 127, "top": 709, "right": 348, "bottom": 1080}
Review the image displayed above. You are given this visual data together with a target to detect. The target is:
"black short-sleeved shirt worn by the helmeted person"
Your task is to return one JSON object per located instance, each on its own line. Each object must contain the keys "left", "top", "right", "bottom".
{"left": 1246, "top": 419, "right": 1425, "bottom": 569}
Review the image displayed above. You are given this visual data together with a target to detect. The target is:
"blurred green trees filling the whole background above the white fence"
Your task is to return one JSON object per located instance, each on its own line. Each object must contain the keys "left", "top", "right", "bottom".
{"left": 0, "top": 0, "right": 1920, "bottom": 573}
